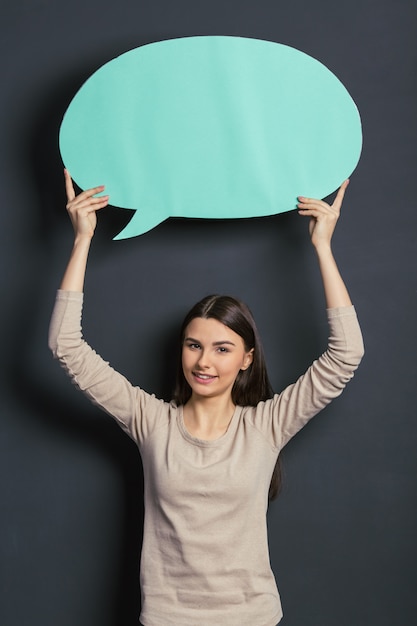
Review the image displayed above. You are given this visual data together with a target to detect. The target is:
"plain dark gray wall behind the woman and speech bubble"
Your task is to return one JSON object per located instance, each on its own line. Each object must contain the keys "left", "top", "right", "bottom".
{"left": 0, "top": 0, "right": 417, "bottom": 626}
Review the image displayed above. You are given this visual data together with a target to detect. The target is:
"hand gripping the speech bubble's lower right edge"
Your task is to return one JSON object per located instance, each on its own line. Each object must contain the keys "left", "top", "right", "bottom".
{"left": 297, "top": 180, "right": 349, "bottom": 249}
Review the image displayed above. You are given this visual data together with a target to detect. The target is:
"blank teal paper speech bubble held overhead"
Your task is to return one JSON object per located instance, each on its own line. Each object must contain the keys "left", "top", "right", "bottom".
{"left": 59, "top": 36, "right": 362, "bottom": 239}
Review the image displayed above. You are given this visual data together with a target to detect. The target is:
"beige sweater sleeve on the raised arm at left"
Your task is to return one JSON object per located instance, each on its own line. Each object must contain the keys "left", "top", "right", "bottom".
{"left": 49, "top": 290, "right": 167, "bottom": 443}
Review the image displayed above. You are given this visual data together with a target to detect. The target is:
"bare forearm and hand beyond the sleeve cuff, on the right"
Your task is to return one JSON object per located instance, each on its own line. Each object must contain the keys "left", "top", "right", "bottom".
{"left": 298, "top": 180, "right": 352, "bottom": 309}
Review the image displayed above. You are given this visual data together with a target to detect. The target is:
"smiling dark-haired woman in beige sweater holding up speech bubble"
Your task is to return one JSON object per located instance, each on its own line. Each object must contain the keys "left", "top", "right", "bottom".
{"left": 50, "top": 172, "right": 363, "bottom": 626}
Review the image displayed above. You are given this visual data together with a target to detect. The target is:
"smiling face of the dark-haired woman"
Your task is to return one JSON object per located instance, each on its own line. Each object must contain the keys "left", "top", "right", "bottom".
{"left": 182, "top": 317, "right": 253, "bottom": 397}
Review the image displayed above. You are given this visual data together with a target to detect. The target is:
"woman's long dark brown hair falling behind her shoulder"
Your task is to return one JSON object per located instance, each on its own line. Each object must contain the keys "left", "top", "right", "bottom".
{"left": 173, "top": 295, "right": 281, "bottom": 500}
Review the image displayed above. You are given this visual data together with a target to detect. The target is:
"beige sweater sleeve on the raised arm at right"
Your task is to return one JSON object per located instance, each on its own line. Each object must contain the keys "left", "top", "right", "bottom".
{"left": 250, "top": 306, "right": 364, "bottom": 449}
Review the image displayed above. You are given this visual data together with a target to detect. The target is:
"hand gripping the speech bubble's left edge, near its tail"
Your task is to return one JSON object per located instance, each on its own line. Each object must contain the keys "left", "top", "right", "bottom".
{"left": 64, "top": 170, "right": 109, "bottom": 240}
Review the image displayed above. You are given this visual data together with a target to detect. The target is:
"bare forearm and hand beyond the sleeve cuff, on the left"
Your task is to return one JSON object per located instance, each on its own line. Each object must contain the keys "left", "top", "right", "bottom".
{"left": 61, "top": 170, "right": 109, "bottom": 292}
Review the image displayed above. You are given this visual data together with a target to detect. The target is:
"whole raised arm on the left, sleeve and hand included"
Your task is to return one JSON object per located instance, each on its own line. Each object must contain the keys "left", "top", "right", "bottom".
{"left": 49, "top": 171, "right": 167, "bottom": 442}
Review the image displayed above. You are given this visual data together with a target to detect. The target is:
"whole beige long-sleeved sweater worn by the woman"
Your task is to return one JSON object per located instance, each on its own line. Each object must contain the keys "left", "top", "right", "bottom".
{"left": 50, "top": 291, "right": 363, "bottom": 626}
